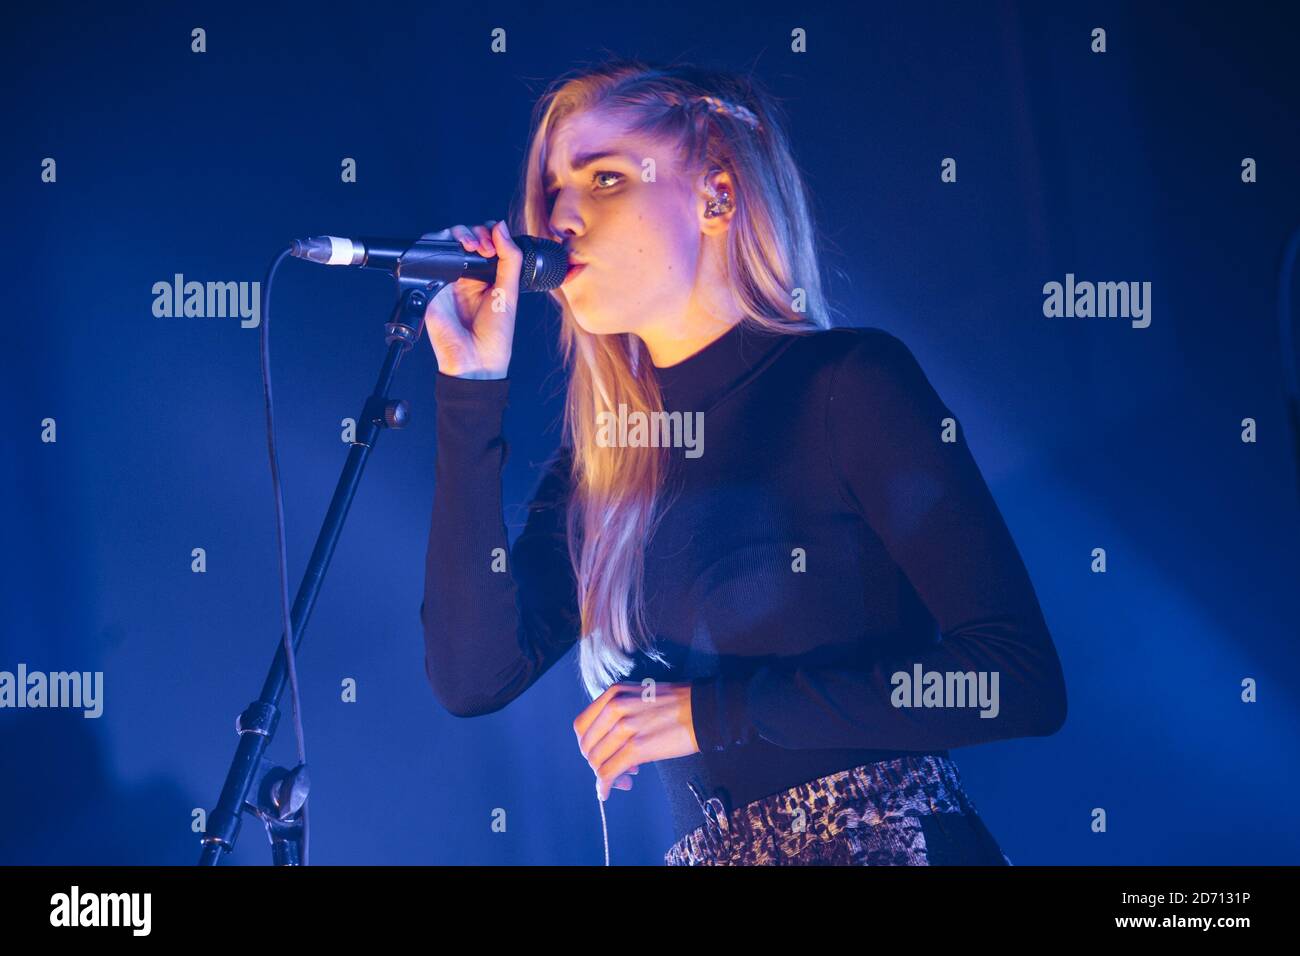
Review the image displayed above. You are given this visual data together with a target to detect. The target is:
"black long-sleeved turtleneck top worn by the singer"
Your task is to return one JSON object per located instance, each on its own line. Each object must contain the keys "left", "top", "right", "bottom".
{"left": 420, "top": 325, "right": 1066, "bottom": 836}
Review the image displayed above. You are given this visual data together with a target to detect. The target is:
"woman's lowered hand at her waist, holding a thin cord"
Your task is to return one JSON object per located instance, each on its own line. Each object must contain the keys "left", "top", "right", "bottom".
{"left": 573, "top": 682, "right": 699, "bottom": 800}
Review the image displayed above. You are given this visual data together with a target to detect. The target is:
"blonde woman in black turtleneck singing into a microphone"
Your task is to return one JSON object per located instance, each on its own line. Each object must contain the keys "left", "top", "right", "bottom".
{"left": 421, "top": 61, "right": 1066, "bottom": 865}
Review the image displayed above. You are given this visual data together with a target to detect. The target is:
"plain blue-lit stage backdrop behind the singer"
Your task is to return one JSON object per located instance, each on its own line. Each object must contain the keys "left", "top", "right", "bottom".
{"left": 0, "top": 3, "right": 1300, "bottom": 865}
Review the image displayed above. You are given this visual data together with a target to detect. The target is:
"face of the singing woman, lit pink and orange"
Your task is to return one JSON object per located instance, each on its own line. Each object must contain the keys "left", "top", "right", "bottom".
{"left": 545, "top": 112, "right": 706, "bottom": 337}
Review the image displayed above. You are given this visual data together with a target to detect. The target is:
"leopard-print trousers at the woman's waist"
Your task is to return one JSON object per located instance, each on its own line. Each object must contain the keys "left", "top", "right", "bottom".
{"left": 664, "top": 754, "right": 1011, "bottom": 866}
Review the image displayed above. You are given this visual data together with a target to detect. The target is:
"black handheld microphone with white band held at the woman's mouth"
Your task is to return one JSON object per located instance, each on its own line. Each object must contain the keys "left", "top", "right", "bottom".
{"left": 290, "top": 235, "right": 569, "bottom": 293}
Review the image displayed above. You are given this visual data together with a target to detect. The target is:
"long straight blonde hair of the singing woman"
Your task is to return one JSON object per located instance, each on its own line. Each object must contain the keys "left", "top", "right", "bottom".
{"left": 511, "top": 60, "right": 829, "bottom": 698}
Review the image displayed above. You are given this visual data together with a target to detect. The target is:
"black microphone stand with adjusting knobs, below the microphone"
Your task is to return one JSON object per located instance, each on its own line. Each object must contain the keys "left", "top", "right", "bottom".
{"left": 199, "top": 268, "right": 446, "bottom": 866}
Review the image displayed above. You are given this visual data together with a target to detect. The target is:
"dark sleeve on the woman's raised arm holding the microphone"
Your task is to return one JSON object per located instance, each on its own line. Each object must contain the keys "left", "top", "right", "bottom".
{"left": 420, "top": 372, "right": 580, "bottom": 717}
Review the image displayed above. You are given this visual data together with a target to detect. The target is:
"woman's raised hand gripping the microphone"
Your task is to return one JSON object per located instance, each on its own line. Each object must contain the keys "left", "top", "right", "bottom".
{"left": 424, "top": 220, "right": 524, "bottom": 378}
